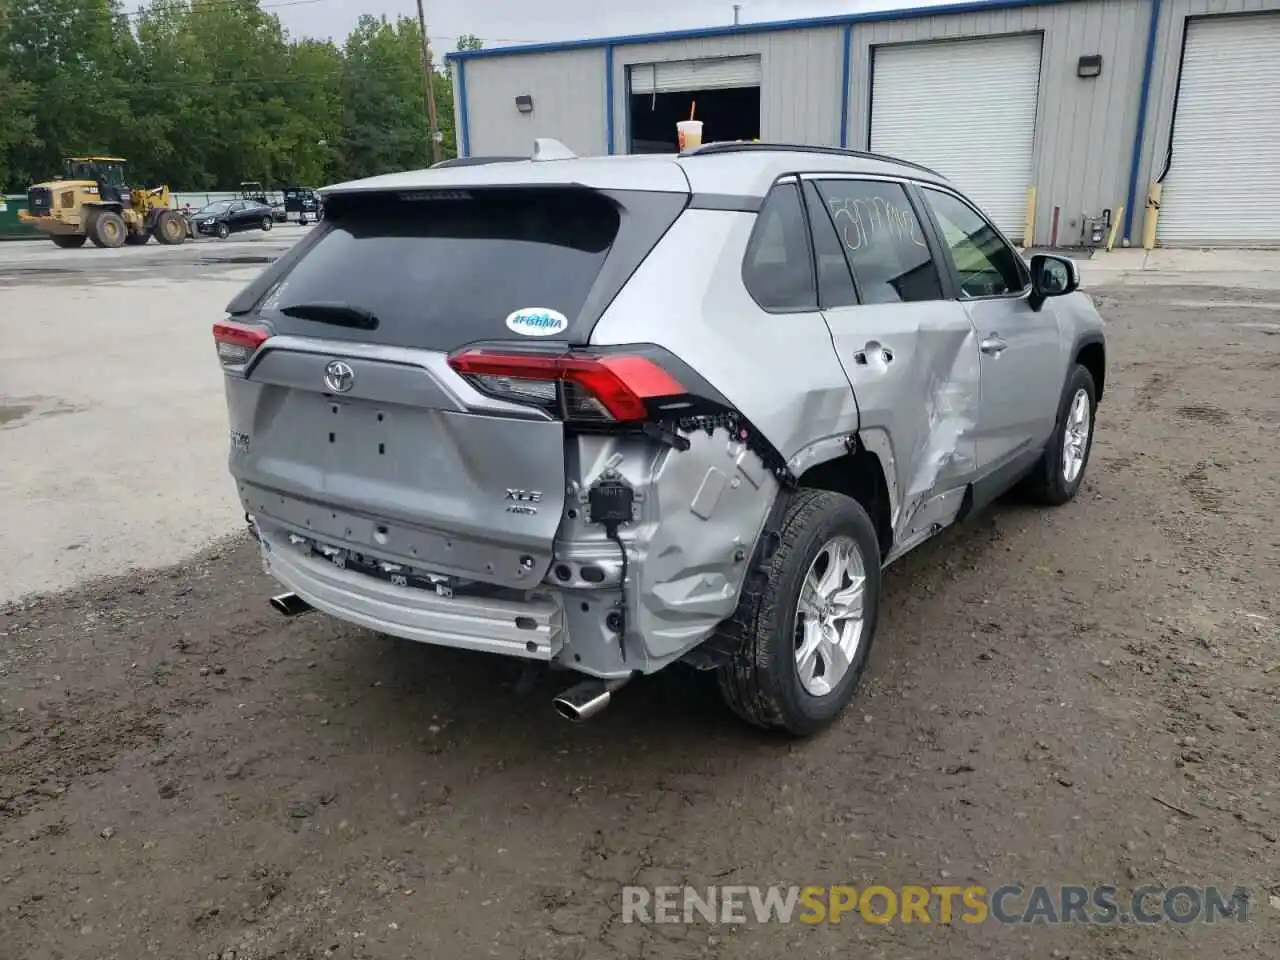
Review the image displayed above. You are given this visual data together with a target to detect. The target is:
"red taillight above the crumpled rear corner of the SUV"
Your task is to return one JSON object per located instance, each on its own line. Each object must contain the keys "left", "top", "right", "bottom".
{"left": 449, "top": 347, "right": 685, "bottom": 422}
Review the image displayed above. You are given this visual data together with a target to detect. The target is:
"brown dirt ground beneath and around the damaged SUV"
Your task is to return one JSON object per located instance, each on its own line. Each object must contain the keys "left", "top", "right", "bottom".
{"left": 0, "top": 285, "right": 1280, "bottom": 960}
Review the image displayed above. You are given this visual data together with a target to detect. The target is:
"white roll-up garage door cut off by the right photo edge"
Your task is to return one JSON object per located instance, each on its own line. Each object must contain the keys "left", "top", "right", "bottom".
{"left": 1162, "top": 14, "right": 1280, "bottom": 246}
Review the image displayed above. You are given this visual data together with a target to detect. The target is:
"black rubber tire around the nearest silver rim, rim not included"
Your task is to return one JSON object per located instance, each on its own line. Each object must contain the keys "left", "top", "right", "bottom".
{"left": 718, "top": 490, "right": 881, "bottom": 737}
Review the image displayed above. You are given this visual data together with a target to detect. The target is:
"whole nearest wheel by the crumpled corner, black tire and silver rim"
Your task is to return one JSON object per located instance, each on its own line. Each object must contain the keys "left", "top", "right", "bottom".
{"left": 719, "top": 490, "right": 881, "bottom": 736}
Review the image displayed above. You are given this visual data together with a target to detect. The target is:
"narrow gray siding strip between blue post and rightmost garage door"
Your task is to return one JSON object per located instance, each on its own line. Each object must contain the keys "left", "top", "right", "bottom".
{"left": 1130, "top": 0, "right": 1280, "bottom": 221}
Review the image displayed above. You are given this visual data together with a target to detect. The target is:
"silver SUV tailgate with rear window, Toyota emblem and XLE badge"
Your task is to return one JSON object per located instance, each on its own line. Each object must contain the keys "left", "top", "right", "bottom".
{"left": 224, "top": 180, "right": 687, "bottom": 588}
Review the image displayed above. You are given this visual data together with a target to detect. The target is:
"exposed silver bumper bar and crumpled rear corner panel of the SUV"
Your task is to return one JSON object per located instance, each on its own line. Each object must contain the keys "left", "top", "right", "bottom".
{"left": 239, "top": 429, "right": 780, "bottom": 681}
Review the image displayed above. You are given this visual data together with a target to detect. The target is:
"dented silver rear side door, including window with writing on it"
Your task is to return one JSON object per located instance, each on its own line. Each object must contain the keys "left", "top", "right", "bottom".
{"left": 805, "top": 175, "right": 979, "bottom": 543}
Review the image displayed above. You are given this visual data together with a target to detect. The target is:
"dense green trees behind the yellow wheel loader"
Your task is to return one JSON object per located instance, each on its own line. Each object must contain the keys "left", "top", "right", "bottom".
{"left": 0, "top": 0, "right": 480, "bottom": 189}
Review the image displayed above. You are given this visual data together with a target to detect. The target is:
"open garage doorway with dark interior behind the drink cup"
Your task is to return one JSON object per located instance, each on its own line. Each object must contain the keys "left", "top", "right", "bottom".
{"left": 627, "top": 56, "right": 760, "bottom": 154}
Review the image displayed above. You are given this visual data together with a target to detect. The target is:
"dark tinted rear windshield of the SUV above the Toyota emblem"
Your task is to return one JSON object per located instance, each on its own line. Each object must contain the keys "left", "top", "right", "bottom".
{"left": 259, "top": 188, "right": 620, "bottom": 349}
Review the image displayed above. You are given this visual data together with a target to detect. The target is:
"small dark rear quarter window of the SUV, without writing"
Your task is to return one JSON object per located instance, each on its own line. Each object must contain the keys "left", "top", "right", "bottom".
{"left": 742, "top": 183, "right": 818, "bottom": 311}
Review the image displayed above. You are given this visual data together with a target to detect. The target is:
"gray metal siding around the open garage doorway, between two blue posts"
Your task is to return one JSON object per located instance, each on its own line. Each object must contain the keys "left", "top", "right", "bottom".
{"left": 611, "top": 27, "right": 844, "bottom": 154}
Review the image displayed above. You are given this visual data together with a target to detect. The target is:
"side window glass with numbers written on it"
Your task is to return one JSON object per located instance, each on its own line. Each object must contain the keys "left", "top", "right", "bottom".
{"left": 818, "top": 180, "right": 942, "bottom": 303}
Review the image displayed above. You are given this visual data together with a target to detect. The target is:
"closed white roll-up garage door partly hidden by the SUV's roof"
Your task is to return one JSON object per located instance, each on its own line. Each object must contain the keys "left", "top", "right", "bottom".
{"left": 870, "top": 33, "right": 1041, "bottom": 241}
